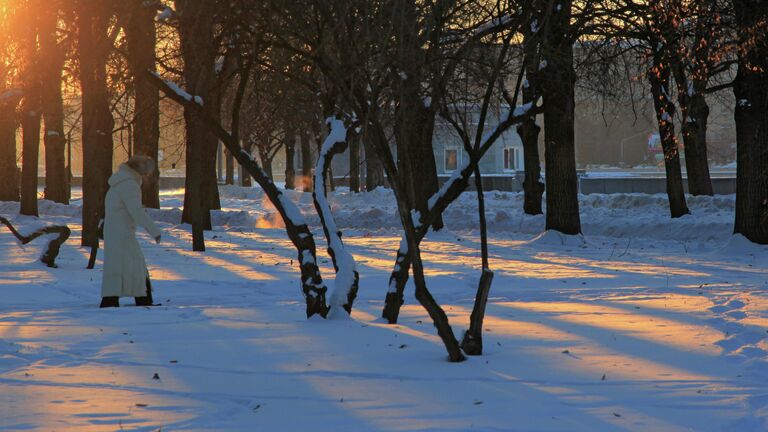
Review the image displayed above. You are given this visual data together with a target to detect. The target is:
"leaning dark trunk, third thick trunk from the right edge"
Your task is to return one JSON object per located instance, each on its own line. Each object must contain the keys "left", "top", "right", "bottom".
{"left": 648, "top": 47, "right": 690, "bottom": 218}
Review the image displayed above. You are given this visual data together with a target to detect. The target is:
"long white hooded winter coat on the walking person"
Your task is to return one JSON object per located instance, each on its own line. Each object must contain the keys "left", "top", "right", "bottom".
{"left": 101, "top": 164, "right": 160, "bottom": 297}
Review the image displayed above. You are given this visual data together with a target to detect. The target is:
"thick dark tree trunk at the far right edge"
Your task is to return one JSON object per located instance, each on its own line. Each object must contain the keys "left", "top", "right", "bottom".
{"left": 733, "top": 0, "right": 768, "bottom": 244}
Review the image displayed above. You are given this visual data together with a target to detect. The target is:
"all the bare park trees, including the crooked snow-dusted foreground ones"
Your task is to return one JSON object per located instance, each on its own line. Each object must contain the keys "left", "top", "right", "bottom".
{"left": 0, "top": 0, "right": 768, "bottom": 361}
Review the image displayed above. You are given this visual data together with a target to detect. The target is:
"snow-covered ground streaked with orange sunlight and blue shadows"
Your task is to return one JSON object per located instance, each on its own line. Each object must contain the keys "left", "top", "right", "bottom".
{"left": 0, "top": 187, "right": 768, "bottom": 431}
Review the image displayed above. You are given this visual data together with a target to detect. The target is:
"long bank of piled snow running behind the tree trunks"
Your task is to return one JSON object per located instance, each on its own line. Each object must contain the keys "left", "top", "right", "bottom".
{"left": 0, "top": 186, "right": 736, "bottom": 244}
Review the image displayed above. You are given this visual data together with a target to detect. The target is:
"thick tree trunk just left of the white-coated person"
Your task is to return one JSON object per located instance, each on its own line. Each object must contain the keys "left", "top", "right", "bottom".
{"left": 77, "top": 2, "right": 114, "bottom": 247}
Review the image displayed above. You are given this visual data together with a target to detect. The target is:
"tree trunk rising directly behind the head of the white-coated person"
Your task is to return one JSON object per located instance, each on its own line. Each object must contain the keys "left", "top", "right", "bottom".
{"left": 125, "top": 0, "right": 160, "bottom": 208}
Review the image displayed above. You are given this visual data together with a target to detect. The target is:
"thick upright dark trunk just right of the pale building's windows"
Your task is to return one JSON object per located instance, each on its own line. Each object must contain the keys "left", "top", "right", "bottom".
{"left": 538, "top": 0, "right": 581, "bottom": 235}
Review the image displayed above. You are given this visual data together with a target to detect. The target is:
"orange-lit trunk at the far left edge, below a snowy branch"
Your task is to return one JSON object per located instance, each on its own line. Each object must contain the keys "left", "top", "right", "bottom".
{"left": 0, "top": 90, "right": 21, "bottom": 201}
